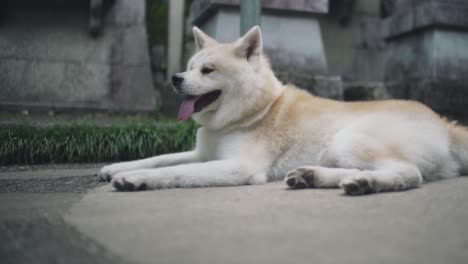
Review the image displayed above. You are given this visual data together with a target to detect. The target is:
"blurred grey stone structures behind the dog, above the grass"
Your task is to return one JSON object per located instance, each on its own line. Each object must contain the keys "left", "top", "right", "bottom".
{"left": 0, "top": 0, "right": 468, "bottom": 119}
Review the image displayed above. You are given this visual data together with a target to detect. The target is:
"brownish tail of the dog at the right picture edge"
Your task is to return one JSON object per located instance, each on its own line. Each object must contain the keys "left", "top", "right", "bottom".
{"left": 449, "top": 122, "right": 468, "bottom": 175}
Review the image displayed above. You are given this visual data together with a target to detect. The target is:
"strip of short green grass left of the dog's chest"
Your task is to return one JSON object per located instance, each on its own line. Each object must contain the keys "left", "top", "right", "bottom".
{"left": 0, "top": 122, "right": 196, "bottom": 165}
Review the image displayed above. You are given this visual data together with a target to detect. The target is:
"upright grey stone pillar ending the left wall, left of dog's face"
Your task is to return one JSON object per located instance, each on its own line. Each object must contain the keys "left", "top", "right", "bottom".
{"left": 104, "top": 0, "right": 159, "bottom": 111}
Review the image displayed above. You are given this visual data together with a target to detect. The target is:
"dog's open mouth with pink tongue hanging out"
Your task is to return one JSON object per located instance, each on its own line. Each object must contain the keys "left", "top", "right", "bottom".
{"left": 178, "top": 90, "right": 221, "bottom": 121}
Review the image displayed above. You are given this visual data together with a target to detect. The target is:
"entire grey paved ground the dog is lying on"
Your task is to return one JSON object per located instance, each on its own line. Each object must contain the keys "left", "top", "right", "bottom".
{"left": 0, "top": 168, "right": 468, "bottom": 264}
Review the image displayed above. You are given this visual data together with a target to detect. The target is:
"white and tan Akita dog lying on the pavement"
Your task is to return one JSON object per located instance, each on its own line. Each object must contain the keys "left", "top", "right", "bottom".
{"left": 100, "top": 26, "right": 468, "bottom": 195}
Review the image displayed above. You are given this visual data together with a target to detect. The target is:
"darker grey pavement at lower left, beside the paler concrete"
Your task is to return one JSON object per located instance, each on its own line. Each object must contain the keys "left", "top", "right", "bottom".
{"left": 0, "top": 165, "right": 131, "bottom": 264}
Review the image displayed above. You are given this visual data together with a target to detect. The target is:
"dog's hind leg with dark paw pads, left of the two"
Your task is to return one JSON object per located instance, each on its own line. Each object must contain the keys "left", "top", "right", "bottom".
{"left": 285, "top": 166, "right": 361, "bottom": 189}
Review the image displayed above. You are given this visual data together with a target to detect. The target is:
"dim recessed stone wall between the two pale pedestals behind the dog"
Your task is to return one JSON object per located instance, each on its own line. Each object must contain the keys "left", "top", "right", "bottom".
{"left": 318, "top": 0, "right": 385, "bottom": 83}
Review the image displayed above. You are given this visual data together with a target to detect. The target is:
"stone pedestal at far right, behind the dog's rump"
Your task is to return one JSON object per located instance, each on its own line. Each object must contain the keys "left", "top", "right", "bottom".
{"left": 383, "top": 0, "right": 468, "bottom": 119}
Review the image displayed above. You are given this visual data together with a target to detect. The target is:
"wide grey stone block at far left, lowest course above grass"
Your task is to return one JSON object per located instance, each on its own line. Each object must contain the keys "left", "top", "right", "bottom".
{"left": 0, "top": 60, "right": 110, "bottom": 108}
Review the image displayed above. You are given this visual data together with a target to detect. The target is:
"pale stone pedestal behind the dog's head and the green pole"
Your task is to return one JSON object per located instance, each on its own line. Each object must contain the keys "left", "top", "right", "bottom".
{"left": 190, "top": 0, "right": 342, "bottom": 99}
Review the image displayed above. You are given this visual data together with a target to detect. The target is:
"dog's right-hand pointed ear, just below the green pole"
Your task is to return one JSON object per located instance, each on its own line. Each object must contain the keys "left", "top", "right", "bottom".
{"left": 234, "top": 26, "right": 263, "bottom": 60}
